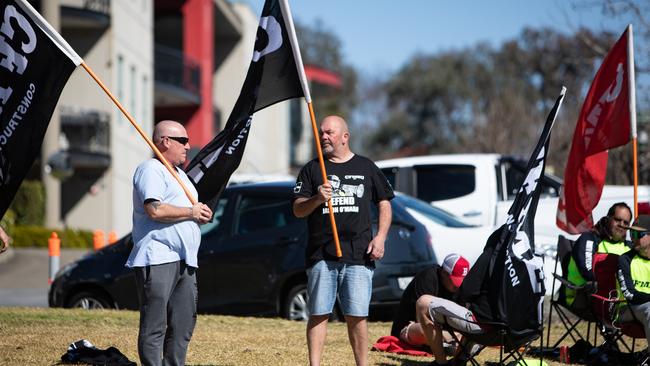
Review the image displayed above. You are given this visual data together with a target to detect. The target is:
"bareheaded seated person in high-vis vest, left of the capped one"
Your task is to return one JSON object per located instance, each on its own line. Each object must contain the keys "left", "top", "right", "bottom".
{"left": 565, "top": 202, "right": 632, "bottom": 305}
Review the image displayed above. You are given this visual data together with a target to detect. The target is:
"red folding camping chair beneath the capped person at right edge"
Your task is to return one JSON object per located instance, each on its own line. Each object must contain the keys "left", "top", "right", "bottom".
{"left": 592, "top": 253, "right": 645, "bottom": 353}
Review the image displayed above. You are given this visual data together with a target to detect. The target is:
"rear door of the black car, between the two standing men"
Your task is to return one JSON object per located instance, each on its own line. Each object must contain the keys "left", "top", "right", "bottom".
{"left": 206, "top": 189, "right": 305, "bottom": 314}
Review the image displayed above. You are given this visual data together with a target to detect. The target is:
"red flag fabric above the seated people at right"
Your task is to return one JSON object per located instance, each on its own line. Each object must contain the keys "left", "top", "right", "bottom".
{"left": 556, "top": 30, "right": 631, "bottom": 234}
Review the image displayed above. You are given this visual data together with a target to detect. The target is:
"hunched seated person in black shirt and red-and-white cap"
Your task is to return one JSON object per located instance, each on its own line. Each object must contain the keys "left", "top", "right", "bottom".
{"left": 390, "top": 254, "right": 469, "bottom": 346}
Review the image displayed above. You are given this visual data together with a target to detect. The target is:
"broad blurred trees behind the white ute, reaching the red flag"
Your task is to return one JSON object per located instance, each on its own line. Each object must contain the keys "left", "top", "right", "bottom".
{"left": 367, "top": 28, "right": 614, "bottom": 179}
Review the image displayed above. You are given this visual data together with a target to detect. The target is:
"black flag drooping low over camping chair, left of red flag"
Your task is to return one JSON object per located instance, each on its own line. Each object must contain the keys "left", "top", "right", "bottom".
{"left": 460, "top": 88, "right": 566, "bottom": 334}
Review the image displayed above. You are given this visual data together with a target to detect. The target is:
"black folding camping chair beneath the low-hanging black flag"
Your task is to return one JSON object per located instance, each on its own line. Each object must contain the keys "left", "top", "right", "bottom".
{"left": 443, "top": 318, "right": 544, "bottom": 366}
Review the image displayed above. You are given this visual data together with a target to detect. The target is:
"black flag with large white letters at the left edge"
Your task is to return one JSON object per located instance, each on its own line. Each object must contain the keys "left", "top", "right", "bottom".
{"left": 0, "top": 0, "right": 83, "bottom": 215}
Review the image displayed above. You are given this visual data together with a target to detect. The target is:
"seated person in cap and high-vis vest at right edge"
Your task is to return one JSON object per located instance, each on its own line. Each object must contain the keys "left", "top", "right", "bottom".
{"left": 617, "top": 215, "right": 650, "bottom": 350}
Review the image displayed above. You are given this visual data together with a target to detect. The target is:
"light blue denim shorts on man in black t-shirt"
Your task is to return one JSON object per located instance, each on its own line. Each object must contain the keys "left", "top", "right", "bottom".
{"left": 307, "top": 260, "right": 373, "bottom": 317}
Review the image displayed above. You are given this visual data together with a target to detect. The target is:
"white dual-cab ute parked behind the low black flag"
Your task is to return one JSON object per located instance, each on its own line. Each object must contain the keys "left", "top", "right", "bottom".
{"left": 377, "top": 154, "right": 650, "bottom": 253}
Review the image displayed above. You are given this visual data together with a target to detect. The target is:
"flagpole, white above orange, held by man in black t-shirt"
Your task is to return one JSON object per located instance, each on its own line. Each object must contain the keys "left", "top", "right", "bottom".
{"left": 280, "top": 0, "right": 343, "bottom": 258}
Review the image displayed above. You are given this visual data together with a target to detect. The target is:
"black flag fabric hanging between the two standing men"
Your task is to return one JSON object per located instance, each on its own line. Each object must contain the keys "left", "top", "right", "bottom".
{"left": 186, "top": 0, "right": 304, "bottom": 206}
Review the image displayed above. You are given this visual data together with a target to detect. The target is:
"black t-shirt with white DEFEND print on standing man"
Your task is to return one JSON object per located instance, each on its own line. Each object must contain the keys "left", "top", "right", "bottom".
{"left": 294, "top": 155, "right": 394, "bottom": 267}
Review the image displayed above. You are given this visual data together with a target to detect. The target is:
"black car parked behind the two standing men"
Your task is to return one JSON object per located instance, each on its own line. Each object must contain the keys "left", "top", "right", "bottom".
{"left": 48, "top": 182, "right": 446, "bottom": 319}
